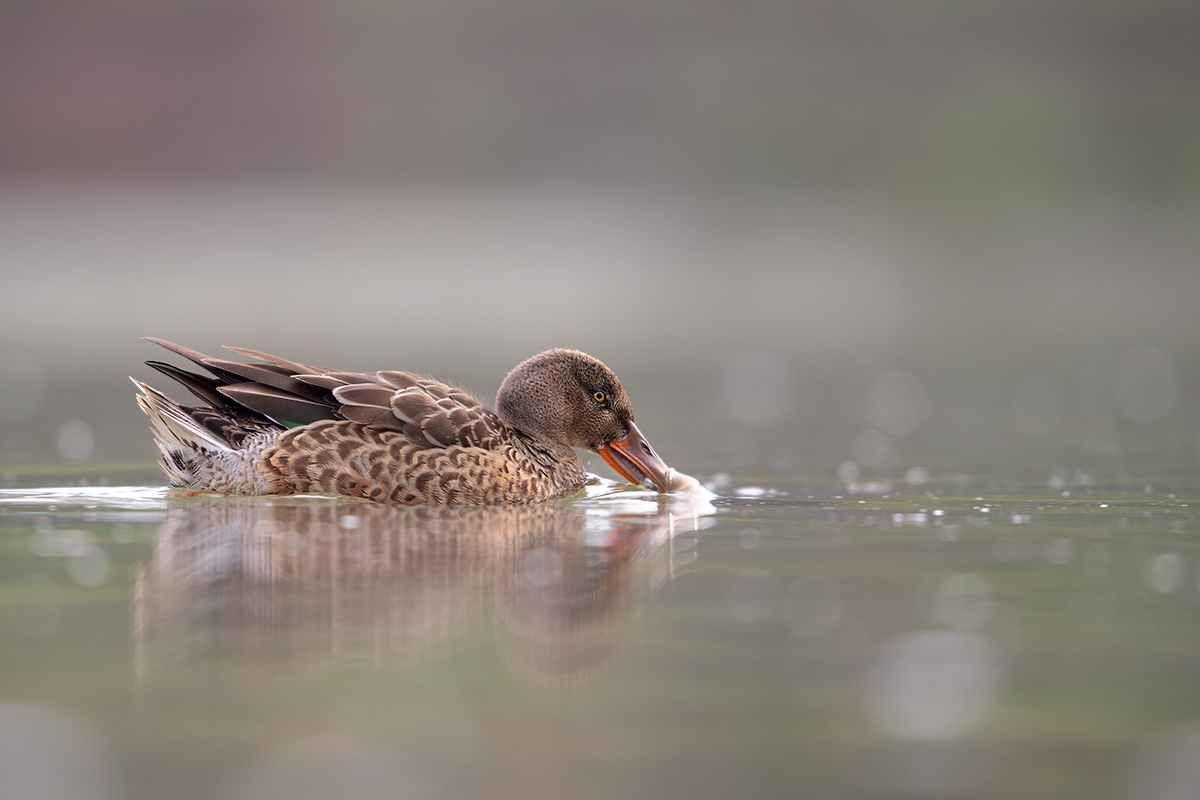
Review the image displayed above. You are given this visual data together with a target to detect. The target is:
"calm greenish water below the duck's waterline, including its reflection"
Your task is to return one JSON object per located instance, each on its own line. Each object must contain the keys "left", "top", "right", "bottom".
{"left": 0, "top": 476, "right": 1200, "bottom": 799}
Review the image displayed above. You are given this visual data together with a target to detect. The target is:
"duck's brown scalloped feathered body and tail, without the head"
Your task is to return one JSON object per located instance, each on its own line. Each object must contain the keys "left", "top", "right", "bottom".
{"left": 134, "top": 339, "right": 609, "bottom": 504}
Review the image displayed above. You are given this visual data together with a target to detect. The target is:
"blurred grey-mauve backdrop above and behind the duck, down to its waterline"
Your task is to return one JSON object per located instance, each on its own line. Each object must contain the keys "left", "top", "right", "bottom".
{"left": 0, "top": 0, "right": 1200, "bottom": 488}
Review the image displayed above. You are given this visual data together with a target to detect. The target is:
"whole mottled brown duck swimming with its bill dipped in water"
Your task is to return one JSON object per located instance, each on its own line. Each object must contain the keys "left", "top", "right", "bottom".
{"left": 131, "top": 337, "right": 676, "bottom": 505}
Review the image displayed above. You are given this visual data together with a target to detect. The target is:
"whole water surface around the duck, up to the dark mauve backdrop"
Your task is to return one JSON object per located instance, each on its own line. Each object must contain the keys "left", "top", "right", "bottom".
{"left": 0, "top": 185, "right": 1200, "bottom": 800}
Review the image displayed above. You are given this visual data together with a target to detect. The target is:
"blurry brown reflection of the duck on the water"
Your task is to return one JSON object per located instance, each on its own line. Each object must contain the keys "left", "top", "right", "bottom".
{"left": 133, "top": 498, "right": 712, "bottom": 684}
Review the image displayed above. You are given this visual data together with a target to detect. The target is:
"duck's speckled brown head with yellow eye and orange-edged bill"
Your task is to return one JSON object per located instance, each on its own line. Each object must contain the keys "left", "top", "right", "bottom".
{"left": 496, "top": 350, "right": 672, "bottom": 492}
